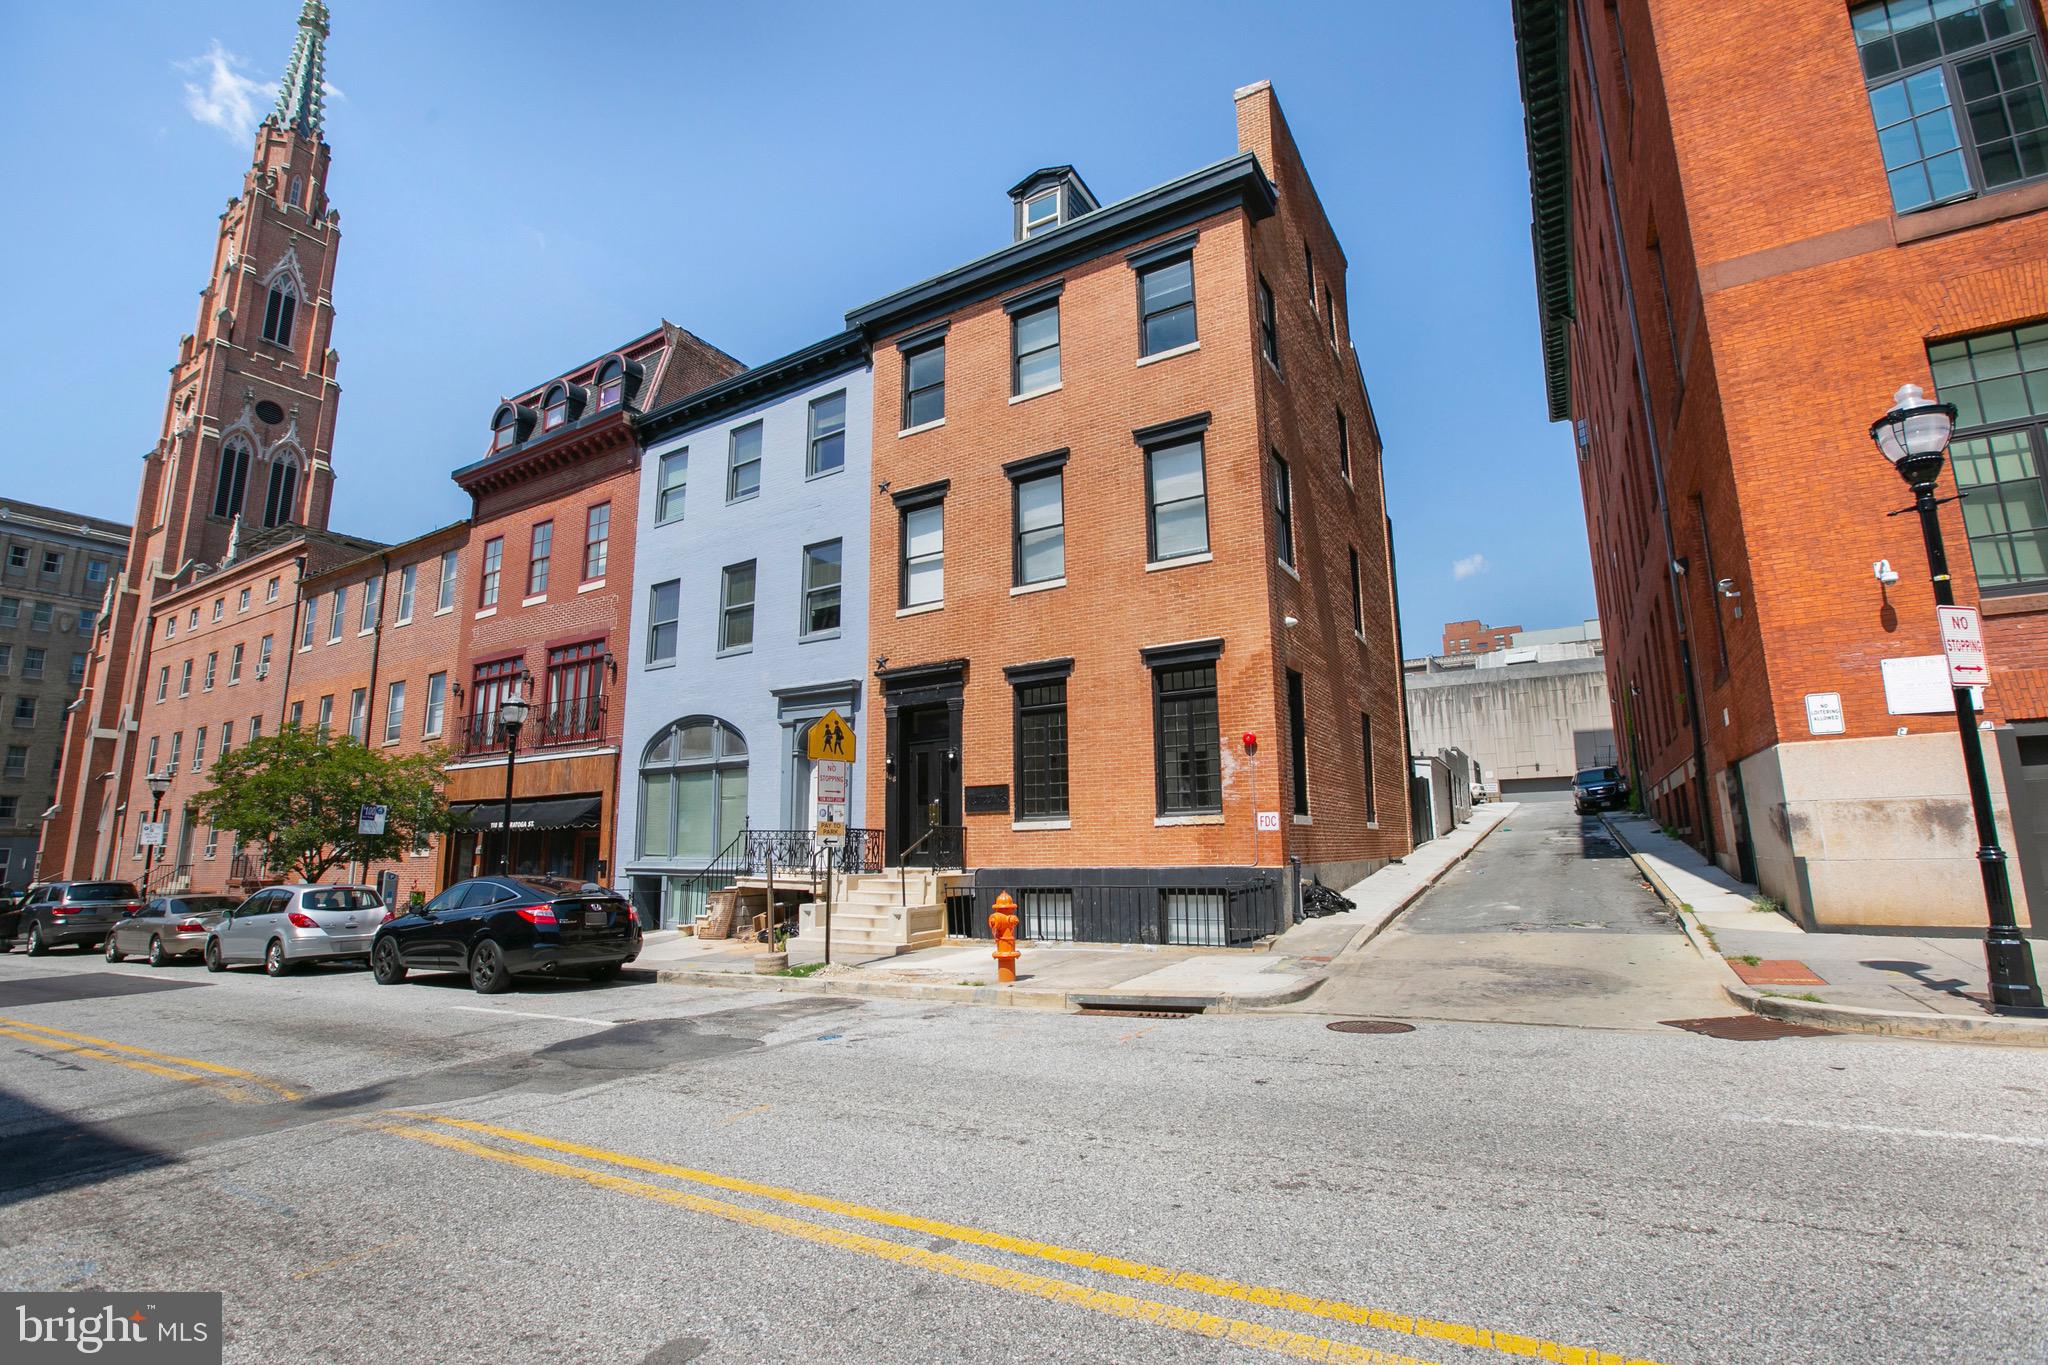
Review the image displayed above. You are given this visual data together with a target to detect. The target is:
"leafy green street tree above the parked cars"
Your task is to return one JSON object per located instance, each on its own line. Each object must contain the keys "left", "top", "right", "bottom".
{"left": 193, "top": 724, "right": 457, "bottom": 882}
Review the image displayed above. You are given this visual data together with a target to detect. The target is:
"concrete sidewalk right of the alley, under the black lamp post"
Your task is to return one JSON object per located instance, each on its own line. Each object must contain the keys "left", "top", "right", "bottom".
{"left": 1608, "top": 814, "right": 2048, "bottom": 1048}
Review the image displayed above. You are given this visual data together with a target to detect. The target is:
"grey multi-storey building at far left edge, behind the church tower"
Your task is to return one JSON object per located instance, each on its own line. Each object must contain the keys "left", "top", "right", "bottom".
{"left": 0, "top": 497, "right": 129, "bottom": 888}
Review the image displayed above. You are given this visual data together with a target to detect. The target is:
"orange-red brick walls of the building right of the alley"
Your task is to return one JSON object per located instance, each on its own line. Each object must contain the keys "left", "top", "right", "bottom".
{"left": 1569, "top": 0, "right": 2048, "bottom": 849}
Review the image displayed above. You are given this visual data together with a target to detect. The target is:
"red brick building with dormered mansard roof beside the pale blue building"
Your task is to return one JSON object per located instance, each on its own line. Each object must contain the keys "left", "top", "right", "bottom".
{"left": 446, "top": 321, "right": 743, "bottom": 880}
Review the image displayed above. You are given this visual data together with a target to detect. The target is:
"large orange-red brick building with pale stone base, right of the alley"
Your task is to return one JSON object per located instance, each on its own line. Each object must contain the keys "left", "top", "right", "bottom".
{"left": 1513, "top": 0, "right": 2048, "bottom": 935}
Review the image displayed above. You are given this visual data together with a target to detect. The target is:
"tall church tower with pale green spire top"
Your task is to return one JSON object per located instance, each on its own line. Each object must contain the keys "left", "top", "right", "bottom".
{"left": 37, "top": 0, "right": 340, "bottom": 880}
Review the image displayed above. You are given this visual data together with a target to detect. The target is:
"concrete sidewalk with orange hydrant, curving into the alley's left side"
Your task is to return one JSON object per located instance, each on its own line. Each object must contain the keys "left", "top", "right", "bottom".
{"left": 633, "top": 804, "right": 1516, "bottom": 1013}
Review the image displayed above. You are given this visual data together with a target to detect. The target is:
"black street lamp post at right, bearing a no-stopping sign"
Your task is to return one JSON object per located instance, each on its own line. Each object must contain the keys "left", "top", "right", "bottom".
{"left": 1870, "top": 385, "right": 2048, "bottom": 1015}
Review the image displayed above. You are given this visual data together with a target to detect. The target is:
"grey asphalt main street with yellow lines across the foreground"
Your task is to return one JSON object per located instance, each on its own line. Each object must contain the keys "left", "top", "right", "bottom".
{"left": 0, "top": 925, "right": 2048, "bottom": 1365}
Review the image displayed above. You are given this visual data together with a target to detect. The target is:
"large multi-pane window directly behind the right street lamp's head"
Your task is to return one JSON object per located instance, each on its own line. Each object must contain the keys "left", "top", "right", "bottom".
{"left": 1927, "top": 323, "right": 2048, "bottom": 596}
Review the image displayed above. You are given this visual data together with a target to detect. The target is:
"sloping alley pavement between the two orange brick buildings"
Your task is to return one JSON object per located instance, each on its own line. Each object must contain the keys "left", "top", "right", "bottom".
{"left": 1296, "top": 800, "right": 1733, "bottom": 1029}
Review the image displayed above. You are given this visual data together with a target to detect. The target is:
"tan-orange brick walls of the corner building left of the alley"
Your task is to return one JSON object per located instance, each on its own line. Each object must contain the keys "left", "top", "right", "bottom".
{"left": 864, "top": 86, "right": 1407, "bottom": 888}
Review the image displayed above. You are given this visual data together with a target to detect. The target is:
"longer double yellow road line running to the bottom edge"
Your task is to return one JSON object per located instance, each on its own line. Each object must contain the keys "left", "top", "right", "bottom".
{"left": 375, "top": 1111, "right": 1655, "bottom": 1365}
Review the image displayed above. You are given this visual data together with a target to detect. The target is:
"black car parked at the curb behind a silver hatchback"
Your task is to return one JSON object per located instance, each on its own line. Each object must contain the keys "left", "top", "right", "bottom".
{"left": 371, "top": 876, "right": 641, "bottom": 995}
